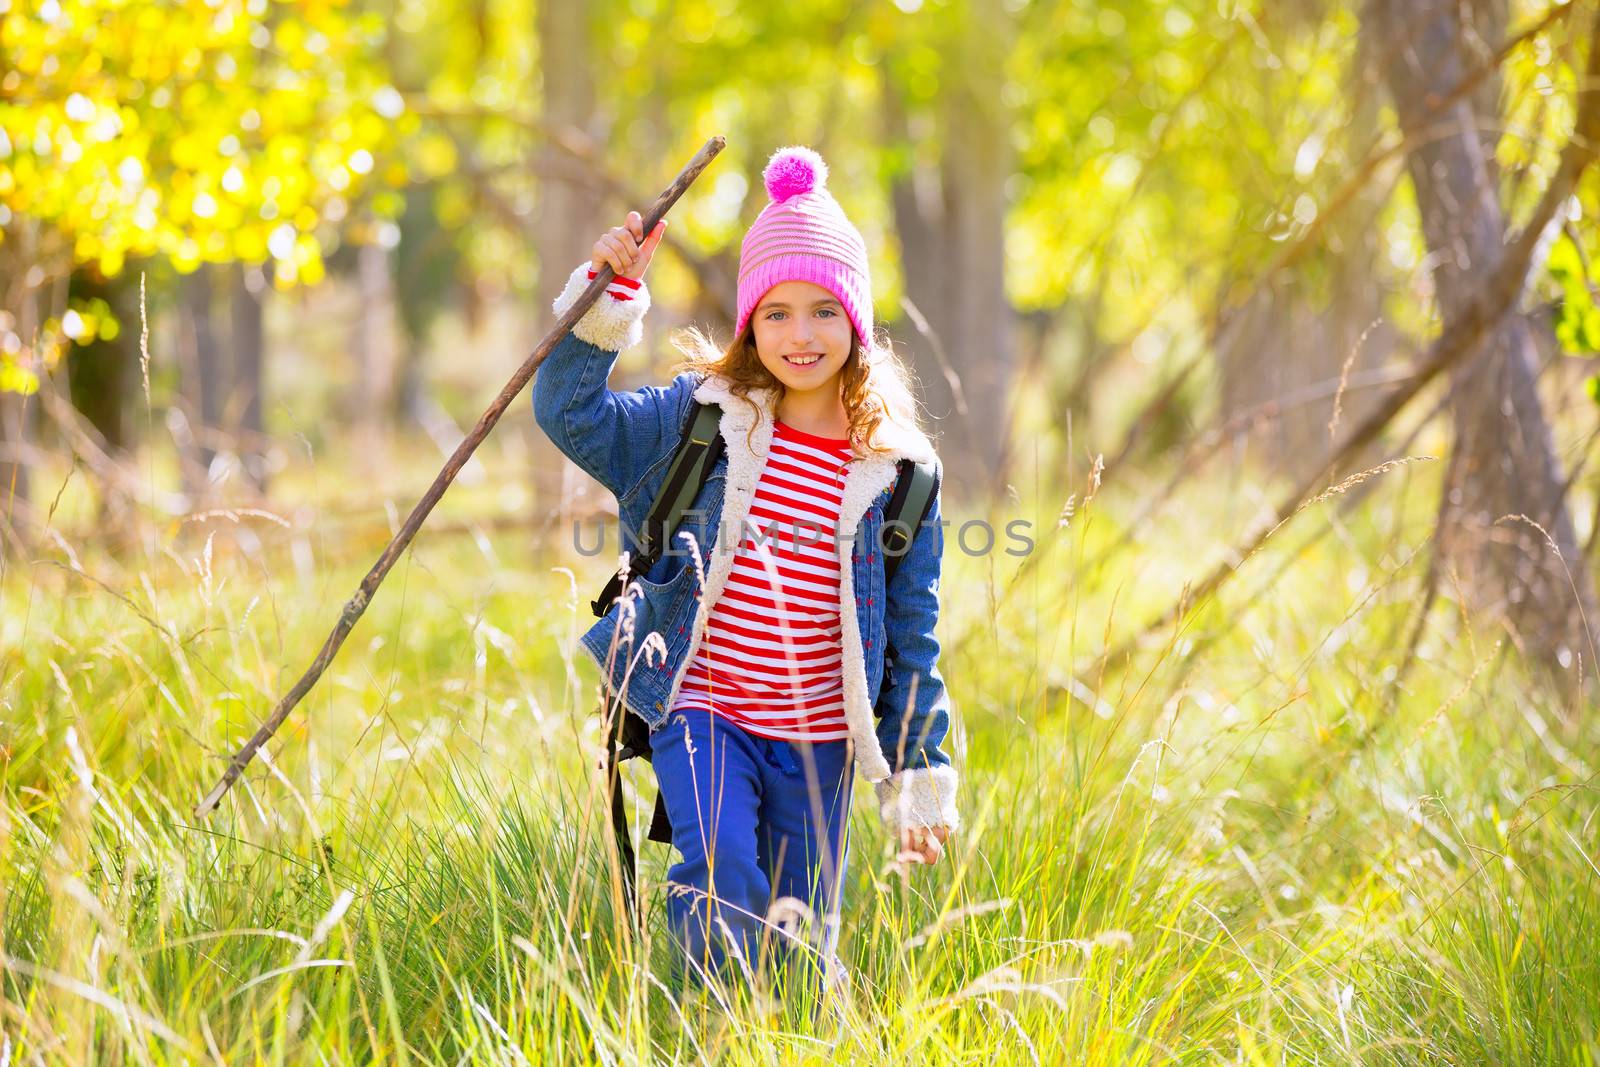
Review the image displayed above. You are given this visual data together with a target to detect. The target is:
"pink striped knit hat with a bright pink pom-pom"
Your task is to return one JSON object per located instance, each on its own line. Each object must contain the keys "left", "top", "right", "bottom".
{"left": 734, "top": 146, "right": 872, "bottom": 346}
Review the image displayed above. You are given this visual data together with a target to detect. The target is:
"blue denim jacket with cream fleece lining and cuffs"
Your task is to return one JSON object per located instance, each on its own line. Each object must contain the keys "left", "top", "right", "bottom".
{"left": 533, "top": 262, "right": 958, "bottom": 829}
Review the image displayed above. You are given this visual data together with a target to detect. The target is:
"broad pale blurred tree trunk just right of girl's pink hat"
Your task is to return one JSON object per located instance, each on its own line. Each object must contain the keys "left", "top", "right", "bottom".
{"left": 885, "top": 2, "right": 1016, "bottom": 499}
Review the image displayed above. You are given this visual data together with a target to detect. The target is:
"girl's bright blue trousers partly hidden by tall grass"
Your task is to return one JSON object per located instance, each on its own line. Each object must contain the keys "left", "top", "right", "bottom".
{"left": 650, "top": 709, "right": 851, "bottom": 976}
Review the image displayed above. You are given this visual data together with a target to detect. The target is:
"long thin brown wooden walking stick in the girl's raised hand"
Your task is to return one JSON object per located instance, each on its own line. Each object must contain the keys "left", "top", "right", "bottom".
{"left": 195, "top": 138, "right": 726, "bottom": 817}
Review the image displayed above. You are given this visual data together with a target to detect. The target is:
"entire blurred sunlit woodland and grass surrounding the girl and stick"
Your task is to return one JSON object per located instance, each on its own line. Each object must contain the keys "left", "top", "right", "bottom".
{"left": 0, "top": 0, "right": 1600, "bottom": 1067}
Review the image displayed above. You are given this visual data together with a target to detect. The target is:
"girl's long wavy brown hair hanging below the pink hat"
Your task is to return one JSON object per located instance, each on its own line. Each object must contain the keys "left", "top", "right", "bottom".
{"left": 670, "top": 315, "right": 922, "bottom": 458}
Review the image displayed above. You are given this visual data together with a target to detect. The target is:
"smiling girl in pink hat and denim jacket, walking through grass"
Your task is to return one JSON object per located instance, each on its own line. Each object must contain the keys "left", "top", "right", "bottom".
{"left": 533, "top": 147, "right": 957, "bottom": 991}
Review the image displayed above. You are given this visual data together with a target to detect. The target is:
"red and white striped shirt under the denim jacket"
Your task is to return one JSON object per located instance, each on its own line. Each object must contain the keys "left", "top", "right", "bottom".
{"left": 674, "top": 421, "right": 851, "bottom": 741}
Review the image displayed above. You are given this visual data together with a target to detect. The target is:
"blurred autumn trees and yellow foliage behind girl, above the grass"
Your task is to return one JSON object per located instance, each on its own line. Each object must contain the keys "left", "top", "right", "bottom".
{"left": 0, "top": 0, "right": 1600, "bottom": 681}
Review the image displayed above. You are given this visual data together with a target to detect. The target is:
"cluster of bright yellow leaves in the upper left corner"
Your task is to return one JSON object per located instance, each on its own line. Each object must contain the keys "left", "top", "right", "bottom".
{"left": 0, "top": 0, "right": 406, "bottom": 294}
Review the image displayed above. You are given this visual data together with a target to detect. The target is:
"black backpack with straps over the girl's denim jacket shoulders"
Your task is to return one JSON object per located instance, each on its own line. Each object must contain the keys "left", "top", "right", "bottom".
{"left": 601, "top": 400, "right": 939, "bottom": 912}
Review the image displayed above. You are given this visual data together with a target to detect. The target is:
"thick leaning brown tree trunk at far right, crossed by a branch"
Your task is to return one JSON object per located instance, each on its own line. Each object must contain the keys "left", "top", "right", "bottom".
{"left": 1370, "top": 0, "right": 1597, "bottom": 673}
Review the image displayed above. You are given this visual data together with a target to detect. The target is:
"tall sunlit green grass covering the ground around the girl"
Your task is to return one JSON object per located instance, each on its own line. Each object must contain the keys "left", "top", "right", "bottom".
{"left": 0, "top": 447, "right": 1600, "bottom": 1064}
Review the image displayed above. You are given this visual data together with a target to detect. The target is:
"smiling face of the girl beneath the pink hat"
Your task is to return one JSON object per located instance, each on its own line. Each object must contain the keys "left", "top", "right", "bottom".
{"left": 750, "top": 282, "right": 854, "bottom": 395}
